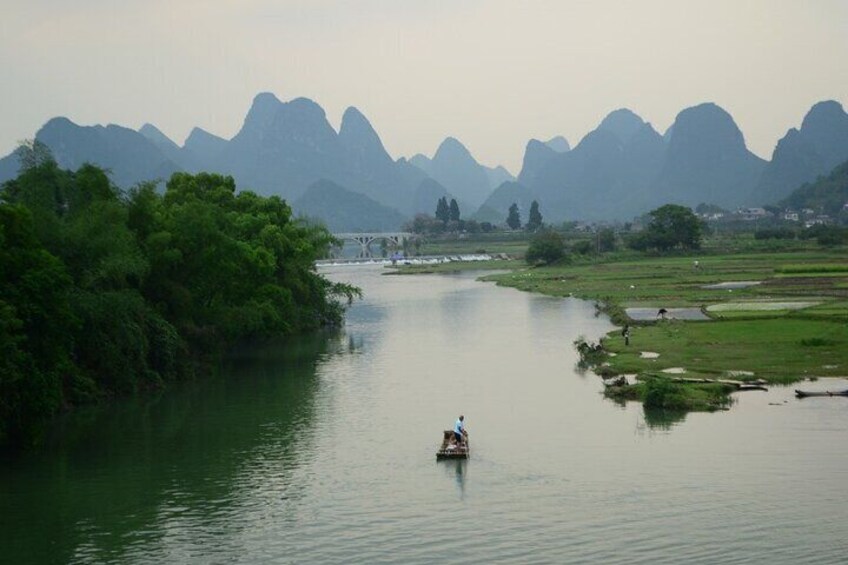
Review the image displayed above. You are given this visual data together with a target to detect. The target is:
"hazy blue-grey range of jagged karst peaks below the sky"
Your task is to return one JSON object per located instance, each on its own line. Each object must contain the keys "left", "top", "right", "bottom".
{"left": 0, "top": 93, "right": 848, "bottom": 225}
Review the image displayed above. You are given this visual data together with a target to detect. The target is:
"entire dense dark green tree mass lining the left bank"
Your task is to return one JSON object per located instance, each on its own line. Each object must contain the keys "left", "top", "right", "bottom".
{"left": 0, "top": 156, "right": 358, "bottom": 444}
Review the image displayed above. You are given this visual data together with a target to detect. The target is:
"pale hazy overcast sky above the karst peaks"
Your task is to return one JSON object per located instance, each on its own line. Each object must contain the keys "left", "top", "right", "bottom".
{"left": 0, "top": 0, "right": 848, "bottom": 174}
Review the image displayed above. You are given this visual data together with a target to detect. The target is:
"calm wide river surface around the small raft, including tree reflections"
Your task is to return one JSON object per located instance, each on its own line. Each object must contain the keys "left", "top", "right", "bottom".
{"left": 0, "top": 266, "right": 848, "bottom": 564}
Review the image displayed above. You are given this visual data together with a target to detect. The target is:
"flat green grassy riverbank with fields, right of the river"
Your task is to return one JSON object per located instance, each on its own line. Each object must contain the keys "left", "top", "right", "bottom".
{"left": 392, "top": 212, "right": 848, "bottom": 414}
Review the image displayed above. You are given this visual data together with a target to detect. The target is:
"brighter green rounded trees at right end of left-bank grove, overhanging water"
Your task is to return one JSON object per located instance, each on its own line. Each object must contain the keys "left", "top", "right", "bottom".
{"left": 138, "top": 173, "right": 356, "bottom": 351}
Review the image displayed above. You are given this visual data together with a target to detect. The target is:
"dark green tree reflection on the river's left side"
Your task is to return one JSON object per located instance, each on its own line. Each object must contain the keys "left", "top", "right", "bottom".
{"left": 0, "top": 335, "right": 334, "bottom": 563}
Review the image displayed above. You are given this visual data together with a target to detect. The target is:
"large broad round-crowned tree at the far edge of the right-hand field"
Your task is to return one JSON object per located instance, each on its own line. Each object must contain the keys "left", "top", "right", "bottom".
{"left": 629, "top": 204, "right": 704, "bottom": 251}
